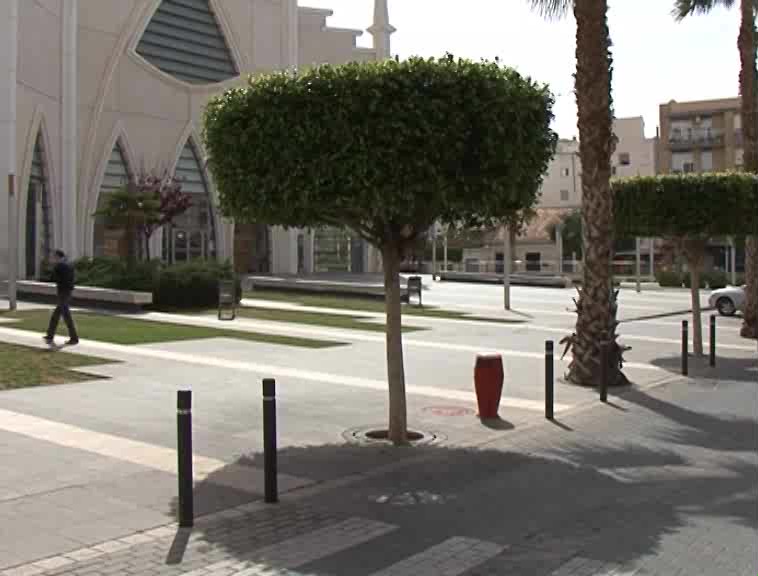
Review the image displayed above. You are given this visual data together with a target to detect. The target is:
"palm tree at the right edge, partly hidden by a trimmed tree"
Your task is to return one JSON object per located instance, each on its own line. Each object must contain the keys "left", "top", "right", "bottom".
{"left": 674, "top": 0, "right": 758, "bottom": 338}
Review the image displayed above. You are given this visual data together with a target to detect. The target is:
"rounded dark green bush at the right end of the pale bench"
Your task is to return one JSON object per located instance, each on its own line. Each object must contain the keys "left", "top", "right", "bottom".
{"left": 153, "top": 261, "right": 242, "bottom": 308}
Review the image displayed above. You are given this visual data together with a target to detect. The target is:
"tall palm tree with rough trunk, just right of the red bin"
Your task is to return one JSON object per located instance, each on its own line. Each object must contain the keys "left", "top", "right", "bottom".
{"left": 530, "top": 0, "right": 626, "bottom": 386}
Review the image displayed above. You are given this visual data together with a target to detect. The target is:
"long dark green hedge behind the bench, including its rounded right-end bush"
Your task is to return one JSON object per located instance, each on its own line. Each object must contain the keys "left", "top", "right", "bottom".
{"left": 57, "top": 258, "right": 242, "bottom": 309}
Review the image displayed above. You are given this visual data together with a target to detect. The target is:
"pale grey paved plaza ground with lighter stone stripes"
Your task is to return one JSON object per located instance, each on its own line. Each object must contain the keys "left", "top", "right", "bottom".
{"left": 0, "top": 277, "right": 758, "bottom": 576}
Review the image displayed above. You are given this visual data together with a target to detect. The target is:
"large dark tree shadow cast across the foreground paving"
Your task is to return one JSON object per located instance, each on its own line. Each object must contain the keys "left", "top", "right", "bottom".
{"left": 159, "top": 430, "right": 756, "bottom": 574}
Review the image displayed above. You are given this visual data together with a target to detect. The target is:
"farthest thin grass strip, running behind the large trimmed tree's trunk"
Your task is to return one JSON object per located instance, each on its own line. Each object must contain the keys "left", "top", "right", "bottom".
{"left": 244, "top": 290, "right": 523, "bottom": 330}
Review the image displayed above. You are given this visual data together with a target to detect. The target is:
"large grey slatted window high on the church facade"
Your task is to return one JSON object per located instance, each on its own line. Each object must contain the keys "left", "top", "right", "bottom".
{"left": 137, "top": 0, "right": 238, "bottom": 84}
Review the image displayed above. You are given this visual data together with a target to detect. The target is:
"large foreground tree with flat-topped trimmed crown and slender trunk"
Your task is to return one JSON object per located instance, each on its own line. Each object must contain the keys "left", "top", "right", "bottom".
{"left": 204, "top": 56, "right": 556, "bottom": 443}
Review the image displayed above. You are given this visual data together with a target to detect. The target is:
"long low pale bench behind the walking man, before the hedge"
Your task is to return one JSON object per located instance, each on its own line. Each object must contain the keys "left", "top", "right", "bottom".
{"left": 3, "top": 280, "right": 153, "bottom": 310}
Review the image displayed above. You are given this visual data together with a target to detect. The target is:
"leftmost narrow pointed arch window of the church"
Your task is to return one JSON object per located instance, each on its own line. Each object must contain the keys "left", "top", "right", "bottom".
{"left": 25, "top": 132, "right": 52, "bottom": 278}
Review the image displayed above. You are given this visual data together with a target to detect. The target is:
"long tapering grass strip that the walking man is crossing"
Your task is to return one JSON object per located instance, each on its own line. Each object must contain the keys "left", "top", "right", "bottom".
{"left": 2, "top": 310, "right": 345, "bottom": 348}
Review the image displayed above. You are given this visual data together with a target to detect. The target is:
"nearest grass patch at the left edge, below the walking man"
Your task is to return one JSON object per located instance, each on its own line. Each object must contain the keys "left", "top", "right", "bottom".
{"left": 0, "top": 342, "right": 113, "bottom": 390}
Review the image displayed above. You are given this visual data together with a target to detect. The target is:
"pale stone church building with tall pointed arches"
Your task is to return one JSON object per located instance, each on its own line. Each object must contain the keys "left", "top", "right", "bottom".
{"left": 0, "top": 0, "right": 394, "bottom": 278}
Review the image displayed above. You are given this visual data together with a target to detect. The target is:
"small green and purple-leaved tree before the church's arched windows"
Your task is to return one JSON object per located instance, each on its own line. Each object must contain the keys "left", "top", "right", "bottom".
{"left": 94, "top": 172, "right": 192, "bottom": 264}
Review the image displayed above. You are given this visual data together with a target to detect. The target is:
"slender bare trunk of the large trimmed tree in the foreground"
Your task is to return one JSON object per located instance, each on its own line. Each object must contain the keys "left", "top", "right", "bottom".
{"left": 382, "top": 241, "right": 408, "bottom": 445}
